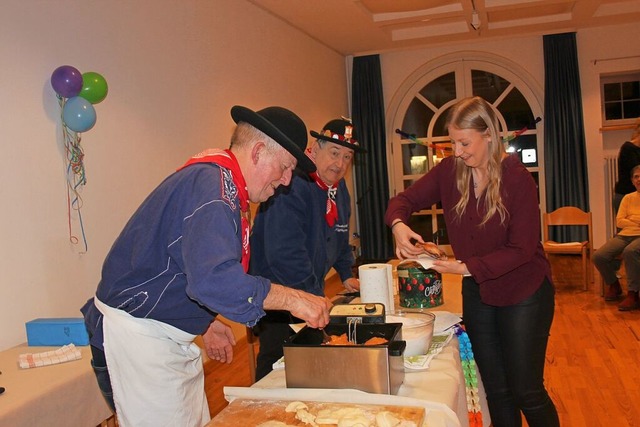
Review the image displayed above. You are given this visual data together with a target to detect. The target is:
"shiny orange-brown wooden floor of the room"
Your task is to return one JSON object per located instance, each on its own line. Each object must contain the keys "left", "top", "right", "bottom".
{"left": 205, "top": 255, "right": 640, "bottom": 427}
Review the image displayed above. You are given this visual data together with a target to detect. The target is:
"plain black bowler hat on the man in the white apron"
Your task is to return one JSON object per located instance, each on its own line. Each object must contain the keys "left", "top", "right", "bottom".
{"left": 231, "top": 105, "right": 316, "bottom": 172}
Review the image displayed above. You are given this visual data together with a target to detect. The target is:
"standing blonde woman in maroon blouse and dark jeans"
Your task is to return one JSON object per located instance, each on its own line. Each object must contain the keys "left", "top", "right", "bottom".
{"left": 385, "top": 97, "right": 559, "bottom": 427}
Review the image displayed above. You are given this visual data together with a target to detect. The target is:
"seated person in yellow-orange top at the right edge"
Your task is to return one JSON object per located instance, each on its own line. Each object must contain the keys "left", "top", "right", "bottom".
{"left": 593, "top": 165, "right": 640, "bottom": 311}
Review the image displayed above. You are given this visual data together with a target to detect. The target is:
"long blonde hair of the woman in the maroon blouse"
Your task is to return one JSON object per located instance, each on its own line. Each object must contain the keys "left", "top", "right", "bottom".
{"left": 445, "top": 96, "right": 508, "bottom": 225}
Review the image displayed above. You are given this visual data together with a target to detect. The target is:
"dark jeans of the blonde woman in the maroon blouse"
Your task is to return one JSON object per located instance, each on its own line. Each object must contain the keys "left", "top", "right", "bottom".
{"left": 462, "top": 277, "right": 560, "bottom": 427}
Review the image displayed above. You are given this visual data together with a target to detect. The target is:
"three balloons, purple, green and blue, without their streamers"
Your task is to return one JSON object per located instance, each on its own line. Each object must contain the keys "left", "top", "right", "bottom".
{"left": 51, "top": 65, "right": 109, "bottom": 132}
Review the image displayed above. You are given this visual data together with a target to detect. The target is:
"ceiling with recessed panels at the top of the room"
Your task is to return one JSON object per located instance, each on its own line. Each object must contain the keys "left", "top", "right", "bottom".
{"left": 249, "top": 0, "right": 640, "bottom": 56}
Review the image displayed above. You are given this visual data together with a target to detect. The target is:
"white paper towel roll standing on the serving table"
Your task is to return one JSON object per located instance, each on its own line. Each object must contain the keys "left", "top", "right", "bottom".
{"left": 358, "top": 264, "right": 395, "bottom": 313}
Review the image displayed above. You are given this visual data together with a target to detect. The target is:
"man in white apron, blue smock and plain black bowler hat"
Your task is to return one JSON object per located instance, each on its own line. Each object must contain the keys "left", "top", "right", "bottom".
{"left": 82, "top": 106, "right": 331, "bottom": 427}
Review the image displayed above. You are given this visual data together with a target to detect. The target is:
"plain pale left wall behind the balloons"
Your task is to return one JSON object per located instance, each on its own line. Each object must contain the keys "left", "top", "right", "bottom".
{"left": 0, "top": 0, "right": 348, "bottom": 350}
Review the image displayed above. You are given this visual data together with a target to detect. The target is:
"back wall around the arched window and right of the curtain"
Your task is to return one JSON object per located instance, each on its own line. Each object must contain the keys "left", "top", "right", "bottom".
{"left": 381, "top": 24, "right": 640, "bottom": 248}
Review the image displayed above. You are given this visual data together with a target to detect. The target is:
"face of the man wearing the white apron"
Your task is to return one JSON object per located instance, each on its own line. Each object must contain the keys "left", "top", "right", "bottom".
{"left": 247, "top": 146, "right": 298, "bottom": 203}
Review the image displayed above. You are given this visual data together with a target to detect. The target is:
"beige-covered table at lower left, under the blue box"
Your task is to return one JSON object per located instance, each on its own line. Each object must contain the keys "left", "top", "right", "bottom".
{"left": 0, "top": 344, "right": 112, "bottom": 427}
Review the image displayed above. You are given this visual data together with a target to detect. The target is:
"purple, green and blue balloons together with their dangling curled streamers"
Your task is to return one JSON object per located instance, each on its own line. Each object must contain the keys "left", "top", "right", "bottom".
{"left": 51, "top": 65, "right": 108, "bottom": 252}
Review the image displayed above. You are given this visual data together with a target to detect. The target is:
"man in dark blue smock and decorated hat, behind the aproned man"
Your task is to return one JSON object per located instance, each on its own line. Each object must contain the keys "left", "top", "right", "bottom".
{"left": 249, "top": 119, "right": 365, "bottom": 381}
